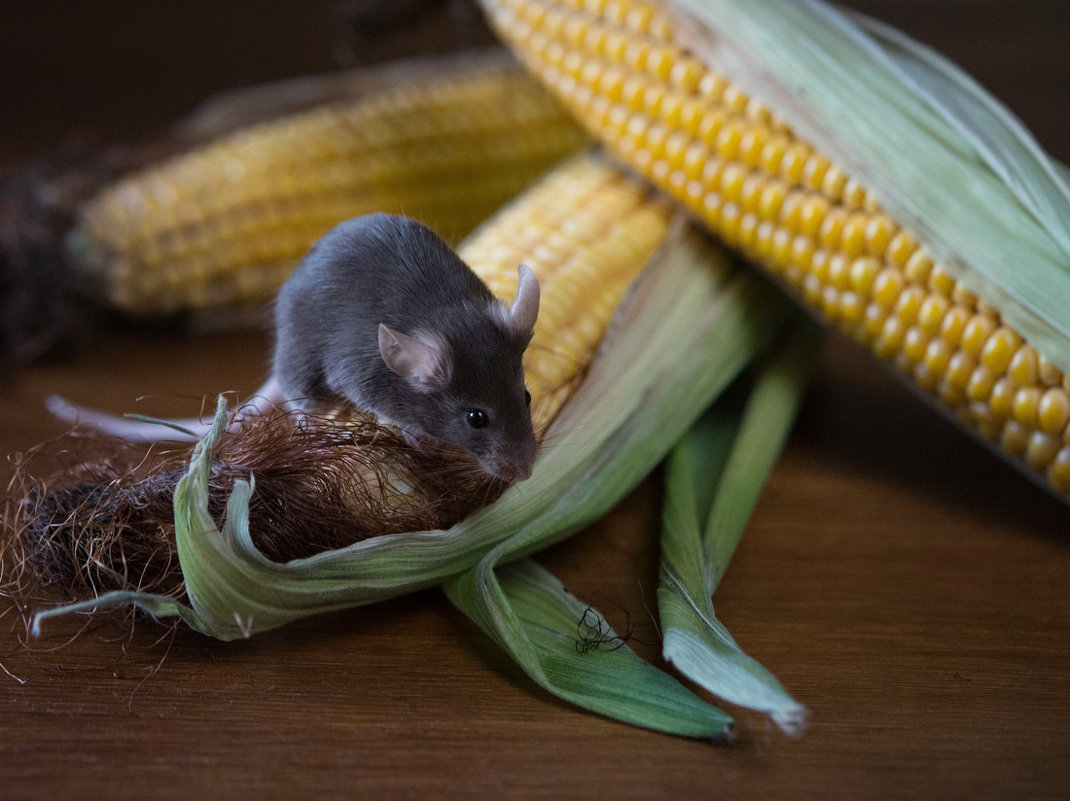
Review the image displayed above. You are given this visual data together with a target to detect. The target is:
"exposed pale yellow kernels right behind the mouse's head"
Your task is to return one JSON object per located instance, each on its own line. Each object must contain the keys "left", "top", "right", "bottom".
{"left": 458, "top": 157, "right": 671, "bottom": 432}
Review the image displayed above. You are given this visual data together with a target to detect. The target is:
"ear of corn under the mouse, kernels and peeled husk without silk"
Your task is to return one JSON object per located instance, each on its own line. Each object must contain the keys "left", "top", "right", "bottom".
{"left": 35, "top": 152, "right": 790, "bottom": 737}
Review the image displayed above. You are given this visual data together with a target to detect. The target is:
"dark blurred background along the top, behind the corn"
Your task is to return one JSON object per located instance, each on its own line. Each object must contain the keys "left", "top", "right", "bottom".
{"left": 0, "top": 0, "right": 1070, "bottom": 160}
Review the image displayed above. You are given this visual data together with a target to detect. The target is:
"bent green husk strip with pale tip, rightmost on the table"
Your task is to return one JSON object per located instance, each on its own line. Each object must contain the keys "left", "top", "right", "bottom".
{"left": 658, "top": 317, "right": 821, "bottom": 736}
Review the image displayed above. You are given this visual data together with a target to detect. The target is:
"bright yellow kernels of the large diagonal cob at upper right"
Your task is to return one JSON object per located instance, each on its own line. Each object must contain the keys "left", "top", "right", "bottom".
{"left": 485, "top": 0, "right": 1070, "bottom": 492}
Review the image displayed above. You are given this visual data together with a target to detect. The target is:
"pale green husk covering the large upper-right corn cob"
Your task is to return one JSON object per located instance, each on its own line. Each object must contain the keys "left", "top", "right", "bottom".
{"left": 669, "top": 0, "right": 1070, "bottom": 372}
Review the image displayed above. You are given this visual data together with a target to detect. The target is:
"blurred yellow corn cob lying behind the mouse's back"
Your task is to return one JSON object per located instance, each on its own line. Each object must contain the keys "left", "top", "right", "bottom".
{"left": 68, "top": 58, "right": 583, "bottom": 314}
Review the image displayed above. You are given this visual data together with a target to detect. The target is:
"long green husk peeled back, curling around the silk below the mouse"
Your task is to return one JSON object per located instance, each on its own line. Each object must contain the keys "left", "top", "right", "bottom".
{"left": 35, "top": 216, "right": 789, "bottom": 640}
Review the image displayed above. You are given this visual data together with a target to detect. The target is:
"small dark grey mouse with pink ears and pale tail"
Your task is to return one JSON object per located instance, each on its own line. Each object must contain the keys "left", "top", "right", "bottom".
{"left": 46, "top": 213, "right": 539, "bottom": 481}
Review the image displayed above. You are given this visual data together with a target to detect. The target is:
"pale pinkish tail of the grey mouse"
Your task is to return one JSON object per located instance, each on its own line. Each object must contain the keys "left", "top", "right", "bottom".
{"left": 45, "top": 380, "right": 284, "bottom": 443}
